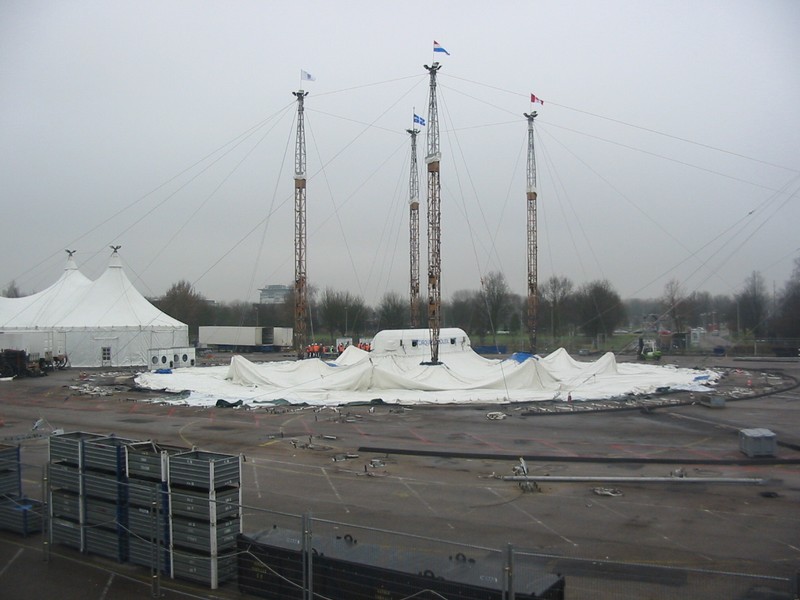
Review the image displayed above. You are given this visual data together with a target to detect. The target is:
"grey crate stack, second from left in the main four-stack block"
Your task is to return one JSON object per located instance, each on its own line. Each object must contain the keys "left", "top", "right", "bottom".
{"left": 83, "top": 435, "right": 134, "bottom": 562}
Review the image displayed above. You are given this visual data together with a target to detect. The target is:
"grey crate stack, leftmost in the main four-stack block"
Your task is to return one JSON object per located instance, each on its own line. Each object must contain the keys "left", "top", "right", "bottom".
{"left": 48, "top": 431, "right": 103, "bottom": 552}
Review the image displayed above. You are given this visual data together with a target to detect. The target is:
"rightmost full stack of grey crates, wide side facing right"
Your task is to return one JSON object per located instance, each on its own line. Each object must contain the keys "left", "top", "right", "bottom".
{"left": 169, "top": 450, "right": 242, "bottom": 589}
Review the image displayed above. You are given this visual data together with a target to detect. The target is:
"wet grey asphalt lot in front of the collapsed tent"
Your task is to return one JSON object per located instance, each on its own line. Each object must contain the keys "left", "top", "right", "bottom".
{"left": 0, "top": 358, "right": 800, "bottom": 600}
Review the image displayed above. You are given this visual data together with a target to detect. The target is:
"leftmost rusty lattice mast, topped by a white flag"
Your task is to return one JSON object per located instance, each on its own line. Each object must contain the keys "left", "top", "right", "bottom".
{"left": 292, "top": 90, "right": 308, "bottom": 358}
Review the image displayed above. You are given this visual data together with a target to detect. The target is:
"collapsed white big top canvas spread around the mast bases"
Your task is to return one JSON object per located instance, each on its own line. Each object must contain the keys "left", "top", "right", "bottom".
{"left": 136, "top": 328, "right": 719, "bottom": 406}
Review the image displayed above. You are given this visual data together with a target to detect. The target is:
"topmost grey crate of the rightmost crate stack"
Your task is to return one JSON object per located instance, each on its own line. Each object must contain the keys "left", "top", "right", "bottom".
{"left": 169, "top": 450, "right": 242, "bottom": 490}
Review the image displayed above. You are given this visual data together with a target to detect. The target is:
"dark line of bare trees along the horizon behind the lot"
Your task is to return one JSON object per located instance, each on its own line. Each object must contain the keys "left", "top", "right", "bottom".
{"left": 145, "top": 258, "right": 800, "bottom": 344}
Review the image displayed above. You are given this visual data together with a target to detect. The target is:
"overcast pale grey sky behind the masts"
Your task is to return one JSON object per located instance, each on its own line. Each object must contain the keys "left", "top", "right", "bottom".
{"left": 0, "top": 0, "right": 800, "bottom": 303}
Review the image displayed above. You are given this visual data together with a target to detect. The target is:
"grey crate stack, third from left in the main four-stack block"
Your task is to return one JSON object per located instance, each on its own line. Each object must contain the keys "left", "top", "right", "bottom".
{"left": 126, "top": 441, "right": 189, "bottom": 575}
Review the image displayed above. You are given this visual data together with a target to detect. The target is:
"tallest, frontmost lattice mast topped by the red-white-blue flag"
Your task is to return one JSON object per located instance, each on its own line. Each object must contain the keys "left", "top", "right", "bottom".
{"left": 424, "top": 62, "right": 442, "bottom": 365}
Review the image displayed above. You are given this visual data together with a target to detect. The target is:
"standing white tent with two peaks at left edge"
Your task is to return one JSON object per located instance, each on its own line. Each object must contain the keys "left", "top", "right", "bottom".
{"left": 0, "top": 251, "right": 189, "bottom": 367}
